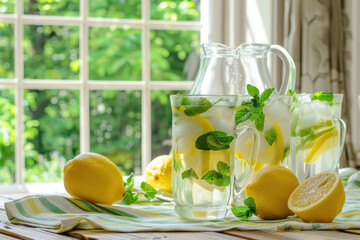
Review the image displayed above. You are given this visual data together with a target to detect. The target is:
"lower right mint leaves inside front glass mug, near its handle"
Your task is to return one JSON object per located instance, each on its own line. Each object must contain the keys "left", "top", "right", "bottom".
{"left": 201, "top": 161, "right": 230, "bottom": 187}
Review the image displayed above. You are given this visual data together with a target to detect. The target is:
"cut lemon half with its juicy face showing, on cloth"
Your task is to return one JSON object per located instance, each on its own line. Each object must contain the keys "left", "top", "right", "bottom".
{"left": 288, "top": 171, "right": 345, "bottom": 223}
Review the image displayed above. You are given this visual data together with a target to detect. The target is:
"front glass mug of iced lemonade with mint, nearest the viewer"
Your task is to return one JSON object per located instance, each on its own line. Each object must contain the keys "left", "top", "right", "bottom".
{"left": 170, "top": 95, "right": 258, "bottom": 219}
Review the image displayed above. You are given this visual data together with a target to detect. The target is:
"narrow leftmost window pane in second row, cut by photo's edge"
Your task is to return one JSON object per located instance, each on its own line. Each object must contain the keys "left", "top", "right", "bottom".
{"left": 0, "top": 23, "right": 14, "bottom": 78}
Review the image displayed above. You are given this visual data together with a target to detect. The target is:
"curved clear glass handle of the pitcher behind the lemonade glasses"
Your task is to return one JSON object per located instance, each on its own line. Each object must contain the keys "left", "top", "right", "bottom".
{"left": 269, "top": 45, "right": 296, "bottom": 94}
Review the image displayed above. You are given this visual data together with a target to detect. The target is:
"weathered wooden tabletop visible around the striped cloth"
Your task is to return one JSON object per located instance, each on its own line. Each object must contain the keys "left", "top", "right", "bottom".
{"left": 0, "top": 193, "right": 360, "bottom": 240}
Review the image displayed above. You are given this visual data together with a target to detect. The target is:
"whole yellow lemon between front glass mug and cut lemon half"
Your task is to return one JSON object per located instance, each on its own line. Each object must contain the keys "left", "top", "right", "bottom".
{"left": 245, "top": 166, "right": 299, "bottom": 220}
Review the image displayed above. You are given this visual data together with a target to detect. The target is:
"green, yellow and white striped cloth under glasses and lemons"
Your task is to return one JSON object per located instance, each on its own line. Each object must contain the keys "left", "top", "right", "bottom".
{"left": 5, "top": 168, "right": 360, "bottom": 233}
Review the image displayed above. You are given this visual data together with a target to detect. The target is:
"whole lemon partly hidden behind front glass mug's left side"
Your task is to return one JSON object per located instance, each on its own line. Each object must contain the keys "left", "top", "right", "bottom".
{"left": 145, "top": 155, "right": 172, "bottom": 192}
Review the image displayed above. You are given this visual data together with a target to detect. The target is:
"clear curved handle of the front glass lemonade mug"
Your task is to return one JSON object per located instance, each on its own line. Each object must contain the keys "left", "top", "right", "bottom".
{"left": 234, "top": 126, "right": 260, "bottom": 206}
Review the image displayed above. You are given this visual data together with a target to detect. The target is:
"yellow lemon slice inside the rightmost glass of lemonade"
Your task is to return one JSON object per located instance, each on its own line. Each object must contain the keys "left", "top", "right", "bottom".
{"left": 304, "top": 129, "right": 338, "bottom": 163}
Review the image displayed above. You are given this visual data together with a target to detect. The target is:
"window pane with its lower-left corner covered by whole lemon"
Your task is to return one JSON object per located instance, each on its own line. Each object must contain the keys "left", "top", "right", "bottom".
{"left": 90, "top": 90, "right": 141, "bottom": 175}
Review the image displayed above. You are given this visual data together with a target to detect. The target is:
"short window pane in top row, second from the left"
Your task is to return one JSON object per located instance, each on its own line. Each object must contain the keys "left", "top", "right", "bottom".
{"left": 24, "top": 0, "right": 80, "bottom": 16}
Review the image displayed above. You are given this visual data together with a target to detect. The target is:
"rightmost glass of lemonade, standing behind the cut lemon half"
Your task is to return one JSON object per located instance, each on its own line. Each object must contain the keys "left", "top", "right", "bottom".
{"left": 289, "top": 92, "right": 346, "bottom": 182}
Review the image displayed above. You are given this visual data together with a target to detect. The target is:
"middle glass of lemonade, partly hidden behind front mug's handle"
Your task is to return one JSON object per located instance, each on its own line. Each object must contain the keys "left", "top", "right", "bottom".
{"left": 234, "top": 95, "right": 293, "bottom": 205}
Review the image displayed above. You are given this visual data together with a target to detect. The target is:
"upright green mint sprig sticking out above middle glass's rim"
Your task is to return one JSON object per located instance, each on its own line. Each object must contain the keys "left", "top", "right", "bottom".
{"left": 235, "top": 84, "right": 275, "bottom": 131}
